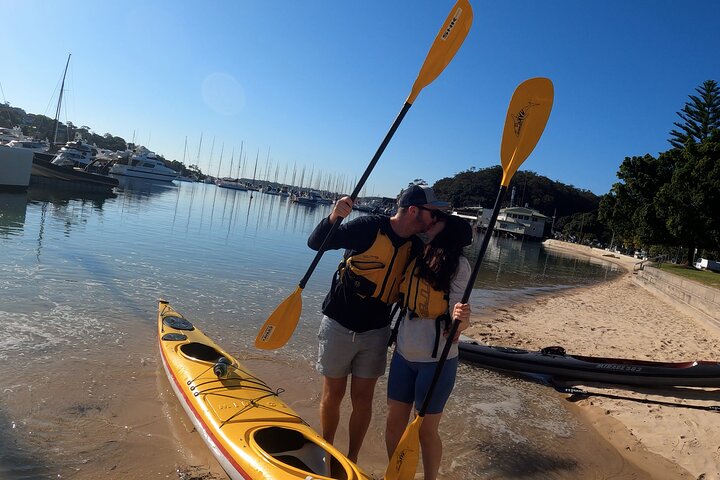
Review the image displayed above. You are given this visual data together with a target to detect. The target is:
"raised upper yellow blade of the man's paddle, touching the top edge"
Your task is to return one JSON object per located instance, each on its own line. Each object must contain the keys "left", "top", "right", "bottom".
{"left": 407, "top": 0, "right": 472, "bottom": 105}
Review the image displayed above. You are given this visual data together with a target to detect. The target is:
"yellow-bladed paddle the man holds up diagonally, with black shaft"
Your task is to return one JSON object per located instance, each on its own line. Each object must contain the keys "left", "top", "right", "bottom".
{"left": 255, "top": 0, "right": 473, "bottom": 350}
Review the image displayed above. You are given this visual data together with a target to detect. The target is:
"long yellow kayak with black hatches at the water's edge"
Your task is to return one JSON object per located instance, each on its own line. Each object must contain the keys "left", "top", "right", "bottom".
{"left": 158, "top": 300, "right": 368, "bottom": 480}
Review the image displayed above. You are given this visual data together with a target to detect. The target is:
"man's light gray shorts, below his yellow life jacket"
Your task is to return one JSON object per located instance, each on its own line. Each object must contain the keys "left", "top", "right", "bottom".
{"left": 316, "top": 316, "right": 390, "bottom": 378}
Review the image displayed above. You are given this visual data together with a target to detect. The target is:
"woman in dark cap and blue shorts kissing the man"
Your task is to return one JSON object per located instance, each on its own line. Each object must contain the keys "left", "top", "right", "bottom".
{"left": 385, "top": 215, "right": 472, "bottom": 480}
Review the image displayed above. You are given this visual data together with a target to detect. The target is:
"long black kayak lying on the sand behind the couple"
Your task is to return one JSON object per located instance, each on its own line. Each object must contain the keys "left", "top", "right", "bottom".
{"left": 459, "top": 340, "right": 720, "bottom": 387}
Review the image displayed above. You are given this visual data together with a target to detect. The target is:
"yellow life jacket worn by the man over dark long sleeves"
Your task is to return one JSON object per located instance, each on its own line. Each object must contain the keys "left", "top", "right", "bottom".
{"left": 338, "top": 230, "right": 412, "bottom": 305}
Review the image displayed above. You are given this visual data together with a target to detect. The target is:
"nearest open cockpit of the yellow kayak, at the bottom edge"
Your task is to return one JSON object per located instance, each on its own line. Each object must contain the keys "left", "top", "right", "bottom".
{"left": 252, "top": 427, "right": 351, "bottom": 480}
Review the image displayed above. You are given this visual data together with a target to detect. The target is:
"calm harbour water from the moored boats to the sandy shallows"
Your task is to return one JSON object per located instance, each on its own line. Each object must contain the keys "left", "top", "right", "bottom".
{"left": 0, "top": 178, "right": 640, "bottom": 479}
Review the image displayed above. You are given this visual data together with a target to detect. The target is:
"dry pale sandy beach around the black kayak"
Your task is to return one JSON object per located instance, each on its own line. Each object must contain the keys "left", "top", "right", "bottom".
{"left": 465, "top": 241, "right": 720, "bottom": 480}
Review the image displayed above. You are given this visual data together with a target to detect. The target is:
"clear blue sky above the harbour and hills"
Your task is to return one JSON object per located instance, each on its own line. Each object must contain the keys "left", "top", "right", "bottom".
{"left": 0, "top": 0, "right": 720, "bottom": 196}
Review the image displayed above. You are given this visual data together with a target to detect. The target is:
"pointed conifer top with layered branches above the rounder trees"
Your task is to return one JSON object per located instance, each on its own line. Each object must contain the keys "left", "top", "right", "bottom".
{"left": 668, "top": 80, "right": 720, "bottom": 148}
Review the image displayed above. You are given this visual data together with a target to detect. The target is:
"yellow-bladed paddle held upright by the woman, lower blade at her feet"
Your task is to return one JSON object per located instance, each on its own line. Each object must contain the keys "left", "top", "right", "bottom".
{"left": 385, "top": 78, "right": 553, "bottom": 480}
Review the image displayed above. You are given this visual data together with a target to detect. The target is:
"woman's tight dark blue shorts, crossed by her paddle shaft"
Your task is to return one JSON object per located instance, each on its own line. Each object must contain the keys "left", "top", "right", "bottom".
{"left": 388, "top": 351, "right": 458, "bottom": 414}
